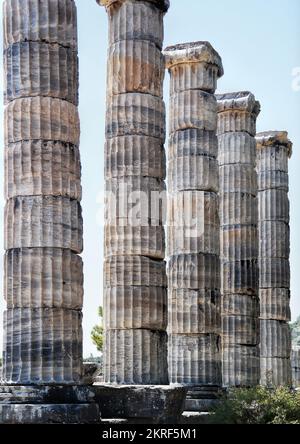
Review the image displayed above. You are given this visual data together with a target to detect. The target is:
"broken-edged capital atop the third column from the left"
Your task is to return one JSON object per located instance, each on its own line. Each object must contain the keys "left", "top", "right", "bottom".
{"left": 163, "top": 41, "right": 224, "bottom": 77}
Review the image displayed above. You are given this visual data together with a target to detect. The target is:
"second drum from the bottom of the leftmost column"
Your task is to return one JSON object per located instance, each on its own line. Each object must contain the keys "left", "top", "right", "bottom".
{"left": 4, "top": 248, "right": 83, "bottom": 310}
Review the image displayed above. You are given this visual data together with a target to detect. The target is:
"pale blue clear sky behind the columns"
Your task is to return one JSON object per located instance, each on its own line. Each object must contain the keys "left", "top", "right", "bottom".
{"left": 0, "top": 0, "right": 300, "bottom": 357}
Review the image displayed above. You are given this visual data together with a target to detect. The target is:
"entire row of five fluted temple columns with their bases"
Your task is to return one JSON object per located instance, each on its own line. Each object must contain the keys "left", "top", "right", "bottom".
{"left": 0, "top": 0, "right": 300, "bottom": 424}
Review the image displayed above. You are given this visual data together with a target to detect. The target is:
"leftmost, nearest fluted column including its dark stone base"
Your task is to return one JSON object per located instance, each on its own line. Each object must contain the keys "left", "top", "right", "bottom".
{"left": 0, "top": 0, "right": 97, "bottom": 422}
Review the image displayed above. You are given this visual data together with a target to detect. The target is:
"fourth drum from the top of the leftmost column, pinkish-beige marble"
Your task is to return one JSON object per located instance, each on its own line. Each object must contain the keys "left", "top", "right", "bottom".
{"left": 4, "top": 140, "right": 82, "bottom": 201}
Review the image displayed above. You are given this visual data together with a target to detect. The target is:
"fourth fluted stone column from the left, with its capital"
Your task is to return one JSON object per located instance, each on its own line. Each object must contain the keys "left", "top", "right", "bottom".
{"left": 217, "top": 92, "right": 260, "bottom": 387}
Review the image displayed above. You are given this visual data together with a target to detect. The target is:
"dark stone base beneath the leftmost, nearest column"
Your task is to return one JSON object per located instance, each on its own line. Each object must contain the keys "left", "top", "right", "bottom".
{"left": 0, "top": 385, "right": 100, "bottom": 424}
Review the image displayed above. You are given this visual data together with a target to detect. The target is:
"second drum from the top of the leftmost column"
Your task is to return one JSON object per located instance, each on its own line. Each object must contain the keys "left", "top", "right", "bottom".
{"left": 4, "top": 42, "right": 79, "bottom": 105}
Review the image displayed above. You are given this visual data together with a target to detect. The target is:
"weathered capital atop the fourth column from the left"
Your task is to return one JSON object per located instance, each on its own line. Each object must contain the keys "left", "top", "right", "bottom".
{"left": 216, "top": 91, "right": 261, "bottom": 117}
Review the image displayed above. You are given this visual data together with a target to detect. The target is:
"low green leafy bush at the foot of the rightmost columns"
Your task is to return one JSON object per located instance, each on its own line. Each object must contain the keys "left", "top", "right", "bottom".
{"left": 211, "top": 387, "right": 300, "bottom": 424}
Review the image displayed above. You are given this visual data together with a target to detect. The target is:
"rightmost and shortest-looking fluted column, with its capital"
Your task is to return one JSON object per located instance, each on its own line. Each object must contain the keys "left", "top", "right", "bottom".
{"left": 256, "top": 131, "right": 292, "bottom": 386}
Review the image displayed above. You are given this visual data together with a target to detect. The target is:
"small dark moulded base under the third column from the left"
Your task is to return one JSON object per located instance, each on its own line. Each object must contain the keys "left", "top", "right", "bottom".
{"left": 185, "top": 387, "right": 223, "bottom": 413}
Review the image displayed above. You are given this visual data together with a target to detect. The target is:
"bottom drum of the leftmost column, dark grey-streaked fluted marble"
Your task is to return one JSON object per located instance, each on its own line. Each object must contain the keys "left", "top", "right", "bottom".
{"left": 3, "top": 308, "right": 82, "bottom": 385}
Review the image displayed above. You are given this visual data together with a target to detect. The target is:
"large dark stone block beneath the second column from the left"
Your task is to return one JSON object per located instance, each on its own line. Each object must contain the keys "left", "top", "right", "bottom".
{"left": 93, "top": 384, "right": 187, "bottom": 424}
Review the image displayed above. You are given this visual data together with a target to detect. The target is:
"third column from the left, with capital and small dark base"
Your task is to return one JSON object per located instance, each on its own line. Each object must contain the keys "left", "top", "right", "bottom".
{"left": 164, "top": 42, "right": 223, "bottom": 411}
